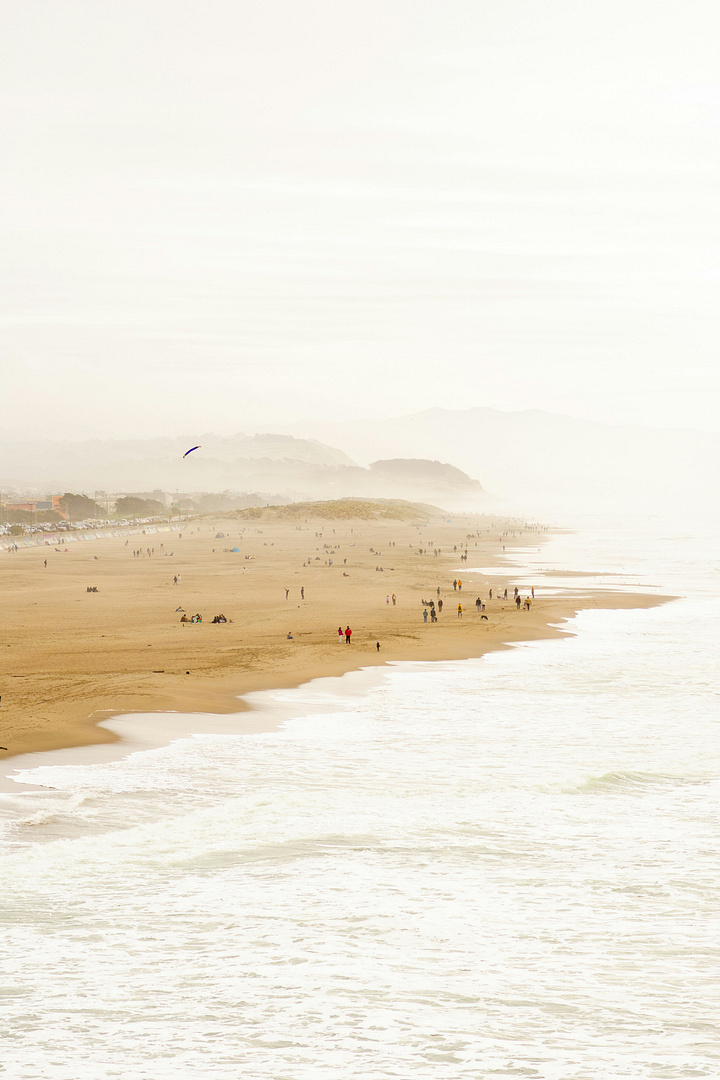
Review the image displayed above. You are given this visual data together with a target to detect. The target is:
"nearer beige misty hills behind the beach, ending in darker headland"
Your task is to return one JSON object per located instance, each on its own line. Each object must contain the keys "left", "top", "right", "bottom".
{"left": 0, "top": 434, "right": 484, "bottom": 508}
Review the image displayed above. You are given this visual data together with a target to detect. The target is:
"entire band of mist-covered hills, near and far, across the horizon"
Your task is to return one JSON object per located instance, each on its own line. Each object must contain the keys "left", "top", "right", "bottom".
{"left": 0, "top": 408, "right": 720, "bottom": 509}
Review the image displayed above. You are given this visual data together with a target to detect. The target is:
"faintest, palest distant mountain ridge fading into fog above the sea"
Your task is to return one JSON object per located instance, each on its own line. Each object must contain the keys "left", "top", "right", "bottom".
{"left": 284, "top": 408, "right": 720, "bottom": 498}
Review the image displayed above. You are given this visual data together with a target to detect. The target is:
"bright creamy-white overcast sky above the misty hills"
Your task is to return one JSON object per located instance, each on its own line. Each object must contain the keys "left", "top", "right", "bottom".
{"left": 0, "top": 0, "right": 720, "bottom": 438}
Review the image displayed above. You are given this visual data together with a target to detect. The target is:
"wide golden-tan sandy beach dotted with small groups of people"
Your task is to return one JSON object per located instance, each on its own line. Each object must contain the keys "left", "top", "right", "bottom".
{"left": 0, "top": 503, "right": 658, "bottom": 757}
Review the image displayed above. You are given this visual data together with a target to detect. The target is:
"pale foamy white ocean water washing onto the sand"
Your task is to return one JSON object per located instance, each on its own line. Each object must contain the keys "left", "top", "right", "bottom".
{"left": 0, "top": 509, "right": 720, "bottom": 1080}
